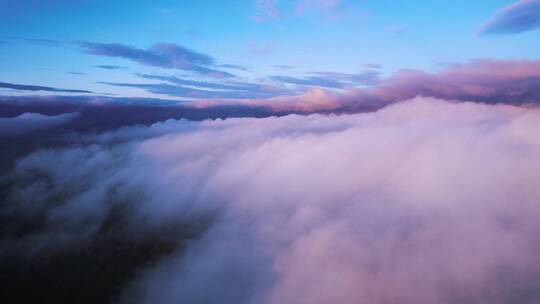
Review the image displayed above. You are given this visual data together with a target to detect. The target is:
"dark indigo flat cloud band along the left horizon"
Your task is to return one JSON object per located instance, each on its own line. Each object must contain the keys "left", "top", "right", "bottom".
{"left": 0, "top": 95, "right": 276, "bottom": 138}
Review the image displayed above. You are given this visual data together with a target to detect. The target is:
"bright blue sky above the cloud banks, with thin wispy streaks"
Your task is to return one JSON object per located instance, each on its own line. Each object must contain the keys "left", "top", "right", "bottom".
{"left": 0, "top": 0, "right": 540, "bottom": 99}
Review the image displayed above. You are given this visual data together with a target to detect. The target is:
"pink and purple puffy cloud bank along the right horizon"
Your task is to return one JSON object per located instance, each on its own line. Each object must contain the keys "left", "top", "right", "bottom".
{"left": 193, "top": 59, "right": 540, "bottom": 113}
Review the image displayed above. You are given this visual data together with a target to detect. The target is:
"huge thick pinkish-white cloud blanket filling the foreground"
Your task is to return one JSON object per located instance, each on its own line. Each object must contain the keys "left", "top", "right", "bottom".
{"left": 3, "top": 98, "right": 540, "bottom": 304}
